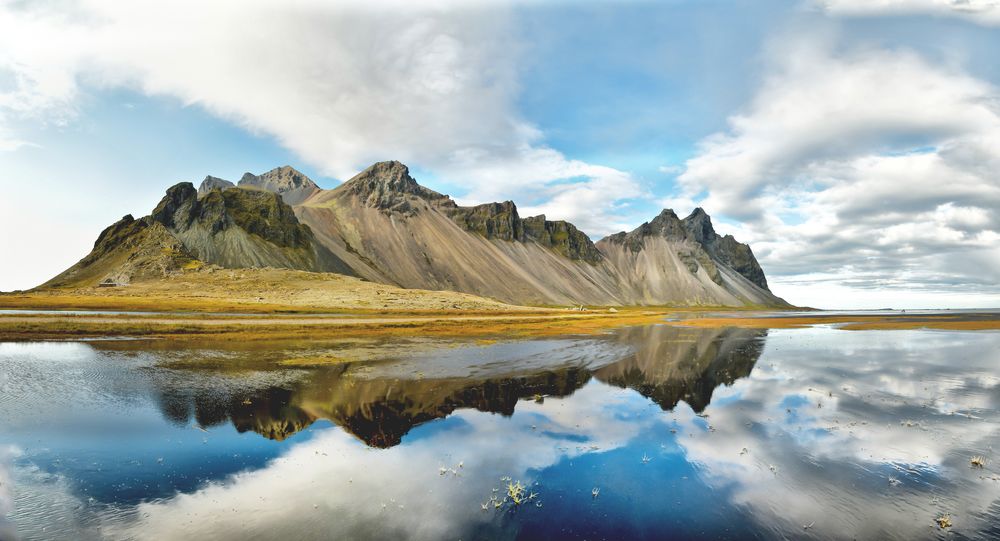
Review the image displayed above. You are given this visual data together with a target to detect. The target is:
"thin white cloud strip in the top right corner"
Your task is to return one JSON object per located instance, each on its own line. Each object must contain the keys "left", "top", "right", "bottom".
{"left": 818, "top": 0, "right": 1000, "bottom": 26}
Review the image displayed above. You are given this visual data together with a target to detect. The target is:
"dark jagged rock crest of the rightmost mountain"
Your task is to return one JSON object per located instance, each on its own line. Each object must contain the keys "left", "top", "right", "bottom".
{"left": 604, "top": 207, "right": 770, "bottom": 291}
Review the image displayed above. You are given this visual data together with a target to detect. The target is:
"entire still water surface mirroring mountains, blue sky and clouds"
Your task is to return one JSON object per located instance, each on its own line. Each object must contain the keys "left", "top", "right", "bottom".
{"left": 0, "top": 326, "right": 1000, "bottom": 541}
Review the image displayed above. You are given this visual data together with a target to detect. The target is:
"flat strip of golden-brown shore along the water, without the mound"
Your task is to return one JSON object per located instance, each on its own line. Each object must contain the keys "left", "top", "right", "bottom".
{"left": 0, "top": 302, "right": 1000, "bottom": 341}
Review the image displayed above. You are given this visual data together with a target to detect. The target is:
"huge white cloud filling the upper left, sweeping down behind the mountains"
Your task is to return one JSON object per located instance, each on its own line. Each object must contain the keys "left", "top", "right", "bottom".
{"left": 0, "top": 0, "right": 638, "bottom": 234}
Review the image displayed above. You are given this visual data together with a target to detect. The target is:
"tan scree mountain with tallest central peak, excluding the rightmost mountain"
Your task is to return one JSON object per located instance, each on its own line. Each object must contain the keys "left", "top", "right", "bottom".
{"left": 296, "top": 162, "right": 625, "bottom": 304}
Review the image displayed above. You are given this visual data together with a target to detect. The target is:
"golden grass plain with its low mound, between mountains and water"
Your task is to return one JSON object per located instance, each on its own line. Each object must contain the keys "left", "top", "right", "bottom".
{"left": 0, "top": 269, "right": 1000, "bottom": 341}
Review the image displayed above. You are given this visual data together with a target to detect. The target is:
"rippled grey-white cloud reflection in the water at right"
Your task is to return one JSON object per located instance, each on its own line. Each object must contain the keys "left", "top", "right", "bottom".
{"left": 679, "top": 329, "right": 1000, "bottom": 539}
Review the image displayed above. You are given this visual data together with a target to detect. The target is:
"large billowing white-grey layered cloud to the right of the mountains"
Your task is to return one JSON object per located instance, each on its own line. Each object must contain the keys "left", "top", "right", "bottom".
{"left": 678, "top": 41, "right": 1000, "bottom": 302}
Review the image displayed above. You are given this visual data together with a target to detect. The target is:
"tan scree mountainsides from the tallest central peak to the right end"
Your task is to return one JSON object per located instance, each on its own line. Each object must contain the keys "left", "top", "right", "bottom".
{"left": 295, "top": 158, "right": 785, "bottom": 306}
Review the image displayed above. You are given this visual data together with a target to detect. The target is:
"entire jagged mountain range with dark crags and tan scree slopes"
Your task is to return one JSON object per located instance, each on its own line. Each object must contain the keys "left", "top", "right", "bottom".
{"left": 41, "top": 161, "right": 788, "bottom": 306}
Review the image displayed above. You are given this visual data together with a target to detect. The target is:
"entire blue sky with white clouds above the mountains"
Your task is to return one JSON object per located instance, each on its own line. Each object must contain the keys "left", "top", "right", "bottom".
{"left": 0, "top": 0, "right": 1000, "bottom": 308}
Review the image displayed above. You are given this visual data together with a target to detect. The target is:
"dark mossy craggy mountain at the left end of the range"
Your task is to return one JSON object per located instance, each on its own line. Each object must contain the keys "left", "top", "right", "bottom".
{"left": 42, "top": 177, "right": 354, "bottom": 288}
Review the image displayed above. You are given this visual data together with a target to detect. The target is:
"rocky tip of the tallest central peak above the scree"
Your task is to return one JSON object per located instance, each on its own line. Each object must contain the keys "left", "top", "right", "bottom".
{"left": 338, "top": 161, "right": 450, "bottom": 213}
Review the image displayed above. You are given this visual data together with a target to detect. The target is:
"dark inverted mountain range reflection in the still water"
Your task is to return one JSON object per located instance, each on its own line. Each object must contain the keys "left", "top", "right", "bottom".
{"left": 148, "top": 326, "right": 766, "bottom": 442}
